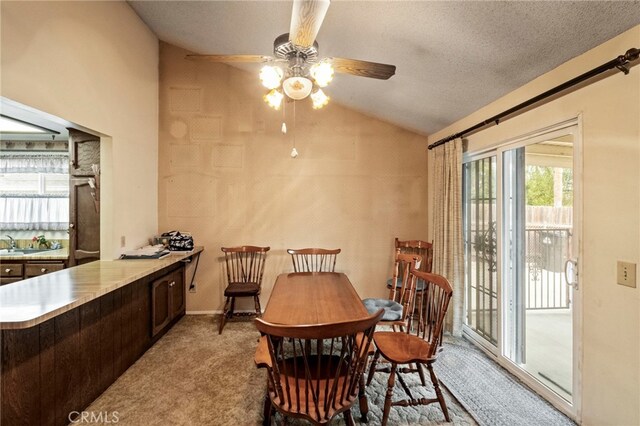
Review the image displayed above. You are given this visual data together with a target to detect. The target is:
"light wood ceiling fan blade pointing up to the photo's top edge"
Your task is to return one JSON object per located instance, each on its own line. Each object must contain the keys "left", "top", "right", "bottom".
{"left": 289, "top": 0, "right": 331, "bottom": 47}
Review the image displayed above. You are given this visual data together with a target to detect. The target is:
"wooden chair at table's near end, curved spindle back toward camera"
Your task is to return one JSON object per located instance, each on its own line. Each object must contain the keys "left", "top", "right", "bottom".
{"left": 255, "top": 310, "right": 383, "bottom": 425}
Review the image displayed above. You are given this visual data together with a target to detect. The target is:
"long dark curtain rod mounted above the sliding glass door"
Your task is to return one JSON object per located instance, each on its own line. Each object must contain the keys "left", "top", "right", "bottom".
{"left": 428, "top": 48, "right": 640, "bottom": 150}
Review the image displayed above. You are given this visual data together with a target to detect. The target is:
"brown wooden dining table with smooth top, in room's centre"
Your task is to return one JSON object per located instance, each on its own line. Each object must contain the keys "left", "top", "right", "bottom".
{"left": 262, "top": 272, "right": 370, "bottom": 422}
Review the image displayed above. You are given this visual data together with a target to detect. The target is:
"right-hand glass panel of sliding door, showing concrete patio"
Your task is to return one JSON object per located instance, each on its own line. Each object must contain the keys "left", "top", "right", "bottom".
{"left": 501, "top": 134, "right": 574, "bottom": 403}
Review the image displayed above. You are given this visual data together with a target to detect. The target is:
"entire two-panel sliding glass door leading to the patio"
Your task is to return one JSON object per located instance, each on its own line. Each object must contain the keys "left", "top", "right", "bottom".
{"left": 463, "top": 120, "right": 580, "bottom": 413}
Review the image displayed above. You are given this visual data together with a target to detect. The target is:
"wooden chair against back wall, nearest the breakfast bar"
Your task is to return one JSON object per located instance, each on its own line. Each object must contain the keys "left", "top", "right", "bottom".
{"left": 218, "top": 246, "right": 270, "bottom": 334}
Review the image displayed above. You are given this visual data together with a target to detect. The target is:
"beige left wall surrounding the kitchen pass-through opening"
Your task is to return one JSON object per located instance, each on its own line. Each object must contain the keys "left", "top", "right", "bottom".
{"left": 0, "top": 1, "right": 158, "bottom": 259}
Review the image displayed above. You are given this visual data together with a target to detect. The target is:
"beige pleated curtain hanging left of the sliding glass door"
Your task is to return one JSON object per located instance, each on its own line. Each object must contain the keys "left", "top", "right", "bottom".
{"left": 432, "top": 139, "right": 464, "bottom": 336}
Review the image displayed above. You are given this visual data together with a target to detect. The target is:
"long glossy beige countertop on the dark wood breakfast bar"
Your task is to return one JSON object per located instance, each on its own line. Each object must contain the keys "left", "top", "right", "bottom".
{"left": 0, "top": 247, "right": 203, "bottom": 330}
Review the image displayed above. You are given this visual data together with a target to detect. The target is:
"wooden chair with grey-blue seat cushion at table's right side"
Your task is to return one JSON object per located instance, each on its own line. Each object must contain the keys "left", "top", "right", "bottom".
{"left": 362, "top": 250, "right": 422, "bottom": 330}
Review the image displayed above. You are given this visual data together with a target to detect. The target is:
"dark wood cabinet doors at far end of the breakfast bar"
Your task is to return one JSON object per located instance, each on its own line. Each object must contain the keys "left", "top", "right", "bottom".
{"left": 151, "top": 268, "right": 185, "bottom": 337}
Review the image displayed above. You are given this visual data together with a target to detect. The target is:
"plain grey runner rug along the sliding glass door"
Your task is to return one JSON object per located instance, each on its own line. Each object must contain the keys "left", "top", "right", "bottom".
{"left": 434, "top": 339, "right": 575, "bottom": 426}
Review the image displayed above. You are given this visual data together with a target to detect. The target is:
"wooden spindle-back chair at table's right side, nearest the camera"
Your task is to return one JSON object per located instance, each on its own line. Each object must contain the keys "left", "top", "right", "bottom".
{"left": 367, "top": 270, "right": 453, "bottom": 426}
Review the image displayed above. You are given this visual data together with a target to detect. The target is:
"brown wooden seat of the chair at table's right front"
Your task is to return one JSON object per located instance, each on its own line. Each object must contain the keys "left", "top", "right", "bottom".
{"left": 373, "top": 331, "right": 433, "bottom": 364}
